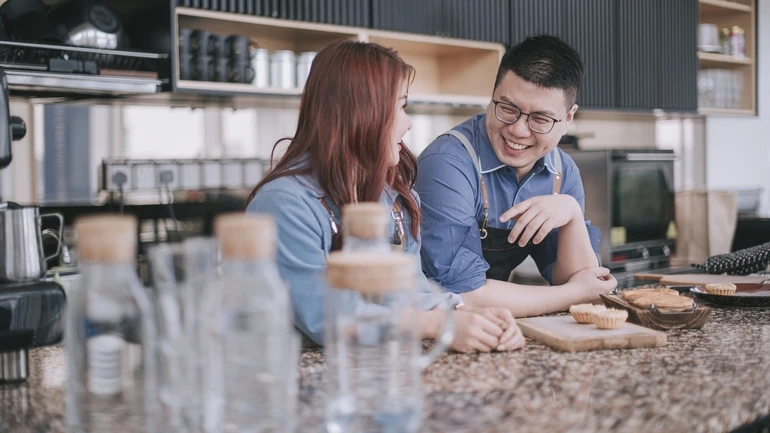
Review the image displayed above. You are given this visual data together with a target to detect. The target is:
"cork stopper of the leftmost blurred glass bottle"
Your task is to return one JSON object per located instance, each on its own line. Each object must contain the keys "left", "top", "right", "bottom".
{"left": 74, "top": 214, "right": 138, "bottom": 263}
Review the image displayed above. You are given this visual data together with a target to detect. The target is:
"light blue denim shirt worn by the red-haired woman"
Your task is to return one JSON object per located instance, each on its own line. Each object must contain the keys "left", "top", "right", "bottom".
{"left": 247, "top": 159, "right": 461, "bottom": 344}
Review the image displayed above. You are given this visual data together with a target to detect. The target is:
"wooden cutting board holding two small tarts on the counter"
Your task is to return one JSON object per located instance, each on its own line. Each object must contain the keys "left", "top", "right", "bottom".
{"left": 516, "top": 316, "right": 666, "bottom": 352}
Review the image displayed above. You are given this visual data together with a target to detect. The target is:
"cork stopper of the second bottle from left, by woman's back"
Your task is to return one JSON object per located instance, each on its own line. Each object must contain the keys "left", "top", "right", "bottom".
{"left": 214, "top": 212, "right": 277, "bottom": 260}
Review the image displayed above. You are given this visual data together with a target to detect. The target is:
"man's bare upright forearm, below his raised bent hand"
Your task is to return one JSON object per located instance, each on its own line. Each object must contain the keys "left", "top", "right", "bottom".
{"left": 551, "top": 220, "right": 599, "bottom": 285}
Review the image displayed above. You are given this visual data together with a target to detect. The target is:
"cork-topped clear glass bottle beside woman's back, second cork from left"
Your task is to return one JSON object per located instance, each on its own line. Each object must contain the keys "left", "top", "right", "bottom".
{"left": 202, "top": 213, "right": 300, "bottom": 433}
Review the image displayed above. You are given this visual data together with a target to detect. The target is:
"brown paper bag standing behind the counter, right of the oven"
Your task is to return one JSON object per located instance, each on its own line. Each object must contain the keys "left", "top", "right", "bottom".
{"left": 671, "top": 190, "right": 738, "bottom": 265}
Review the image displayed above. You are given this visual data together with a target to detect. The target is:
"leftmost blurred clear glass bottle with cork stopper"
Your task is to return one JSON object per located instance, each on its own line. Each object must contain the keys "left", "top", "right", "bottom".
{"left": 64, "top": 215, "right": 157, "bottom": 433}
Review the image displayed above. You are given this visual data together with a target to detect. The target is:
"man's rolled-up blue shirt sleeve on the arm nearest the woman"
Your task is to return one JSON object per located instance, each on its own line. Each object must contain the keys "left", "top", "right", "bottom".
{"left": 415, "top": 153, "right": 489, "bottom": 293}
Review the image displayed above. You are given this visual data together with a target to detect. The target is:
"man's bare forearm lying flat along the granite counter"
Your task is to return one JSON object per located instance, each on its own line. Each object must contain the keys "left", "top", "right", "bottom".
{"left": 462, "top": 280, "right": 586, "bottom": 317}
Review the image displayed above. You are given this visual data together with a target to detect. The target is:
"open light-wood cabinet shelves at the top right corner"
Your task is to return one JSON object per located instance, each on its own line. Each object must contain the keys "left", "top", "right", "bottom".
{"left": 697, "top": 0, "right": 757, "bottom": 116}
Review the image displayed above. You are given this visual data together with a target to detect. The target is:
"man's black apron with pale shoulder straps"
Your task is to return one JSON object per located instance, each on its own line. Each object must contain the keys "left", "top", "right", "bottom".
{"left": 446, "top": 129, "right": 562, "bottom": 281}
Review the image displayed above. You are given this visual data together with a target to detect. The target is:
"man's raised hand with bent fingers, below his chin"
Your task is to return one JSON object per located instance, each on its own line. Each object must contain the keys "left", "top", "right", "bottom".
{"left": 500, "top": 194, "right": 584, "bottom": 247}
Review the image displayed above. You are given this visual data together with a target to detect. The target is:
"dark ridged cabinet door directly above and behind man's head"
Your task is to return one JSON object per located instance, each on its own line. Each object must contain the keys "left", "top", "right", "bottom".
{"left": 510, "top": 0, "right": 617, "bottom": 108}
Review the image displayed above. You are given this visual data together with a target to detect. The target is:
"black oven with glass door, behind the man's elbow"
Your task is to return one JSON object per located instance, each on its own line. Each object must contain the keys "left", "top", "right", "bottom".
{"left": 567, "top": 149, "right": 676, "bottom": 283}
